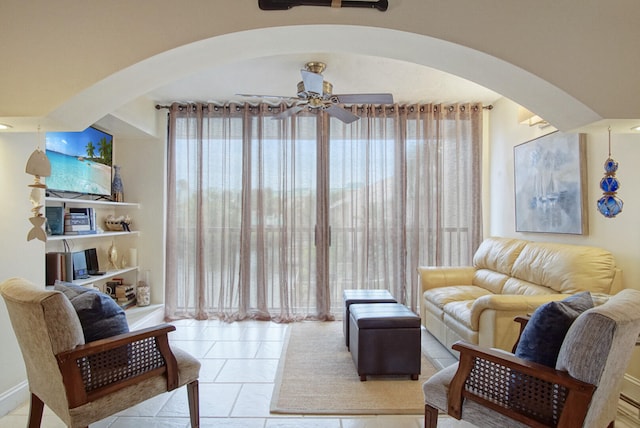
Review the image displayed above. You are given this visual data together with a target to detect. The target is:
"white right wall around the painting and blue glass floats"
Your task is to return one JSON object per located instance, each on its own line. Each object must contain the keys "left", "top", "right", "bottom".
{"left": 485, "top": 99, "right": 640, "bottom": 388}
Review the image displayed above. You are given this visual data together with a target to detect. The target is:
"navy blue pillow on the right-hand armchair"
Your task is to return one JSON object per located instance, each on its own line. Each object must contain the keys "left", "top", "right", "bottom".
{"left": 516, "top": 291, "right": 593, "bottom": 367}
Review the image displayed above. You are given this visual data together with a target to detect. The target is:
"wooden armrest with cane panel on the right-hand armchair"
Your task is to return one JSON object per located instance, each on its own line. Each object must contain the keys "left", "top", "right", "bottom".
{"left": 448, "top": 342, "right": 596, "bottom": 427}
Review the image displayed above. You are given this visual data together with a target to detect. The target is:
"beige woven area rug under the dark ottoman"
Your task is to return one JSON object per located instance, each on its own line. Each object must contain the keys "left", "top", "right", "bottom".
{"left": 271, "top": 321, "right": 437, "bottom": 415}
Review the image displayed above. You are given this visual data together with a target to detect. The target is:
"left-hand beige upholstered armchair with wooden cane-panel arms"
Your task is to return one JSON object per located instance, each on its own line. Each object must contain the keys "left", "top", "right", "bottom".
{"left": 0, "top": 278, "right": 200, "bottom": 427}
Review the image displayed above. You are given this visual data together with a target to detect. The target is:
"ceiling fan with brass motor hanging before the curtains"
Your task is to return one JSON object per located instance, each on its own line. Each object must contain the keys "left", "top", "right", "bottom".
{"left": 237, "top": 61, "right": 393, "bottom": 123}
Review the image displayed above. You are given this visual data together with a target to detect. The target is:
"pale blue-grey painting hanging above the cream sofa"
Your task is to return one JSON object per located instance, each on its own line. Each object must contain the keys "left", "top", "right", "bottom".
{"left": 513, "top": 131, "right": 588, "bottom": 235}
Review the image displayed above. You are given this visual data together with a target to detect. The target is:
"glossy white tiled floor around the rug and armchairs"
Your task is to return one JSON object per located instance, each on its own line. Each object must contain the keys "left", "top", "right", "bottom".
{"left": 0, "top": 320, "right": 638, "bottom": 428}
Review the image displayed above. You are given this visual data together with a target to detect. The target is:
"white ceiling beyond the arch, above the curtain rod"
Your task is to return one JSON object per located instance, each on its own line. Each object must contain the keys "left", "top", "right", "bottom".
{"left": 147, "top": 53, "right": 501, "bottom": 105}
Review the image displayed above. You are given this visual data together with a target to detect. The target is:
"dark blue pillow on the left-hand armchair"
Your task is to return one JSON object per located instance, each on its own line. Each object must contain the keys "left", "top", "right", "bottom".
{"left": 54, "top": 281, "right": 129, "bottom": 343}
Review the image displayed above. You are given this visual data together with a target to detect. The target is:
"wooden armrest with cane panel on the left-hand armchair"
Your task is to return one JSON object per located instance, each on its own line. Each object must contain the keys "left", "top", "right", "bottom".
{"left": 56, "top": 324, "right": 178, "bottom": 408}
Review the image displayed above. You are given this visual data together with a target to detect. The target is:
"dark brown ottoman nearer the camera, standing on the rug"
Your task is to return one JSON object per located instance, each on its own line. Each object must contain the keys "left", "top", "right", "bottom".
{"left": 349, "top": 303, "right": 422, "bottom": 381}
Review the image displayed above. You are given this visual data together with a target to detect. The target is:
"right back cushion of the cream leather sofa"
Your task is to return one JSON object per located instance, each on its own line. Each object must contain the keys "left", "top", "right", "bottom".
{"left": 505, "top": 242, "right": 616, "bottom": 294}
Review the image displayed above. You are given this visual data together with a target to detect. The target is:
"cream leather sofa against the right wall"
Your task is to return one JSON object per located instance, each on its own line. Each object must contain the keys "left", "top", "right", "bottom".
{"left": 418, "top": 237, "right": 622, "bottom": 351}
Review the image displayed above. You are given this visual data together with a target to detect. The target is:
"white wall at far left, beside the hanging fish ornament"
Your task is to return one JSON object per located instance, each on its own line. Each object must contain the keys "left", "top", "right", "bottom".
{"left": 0, "top": 133, "right": 45, "bottom": 415}
